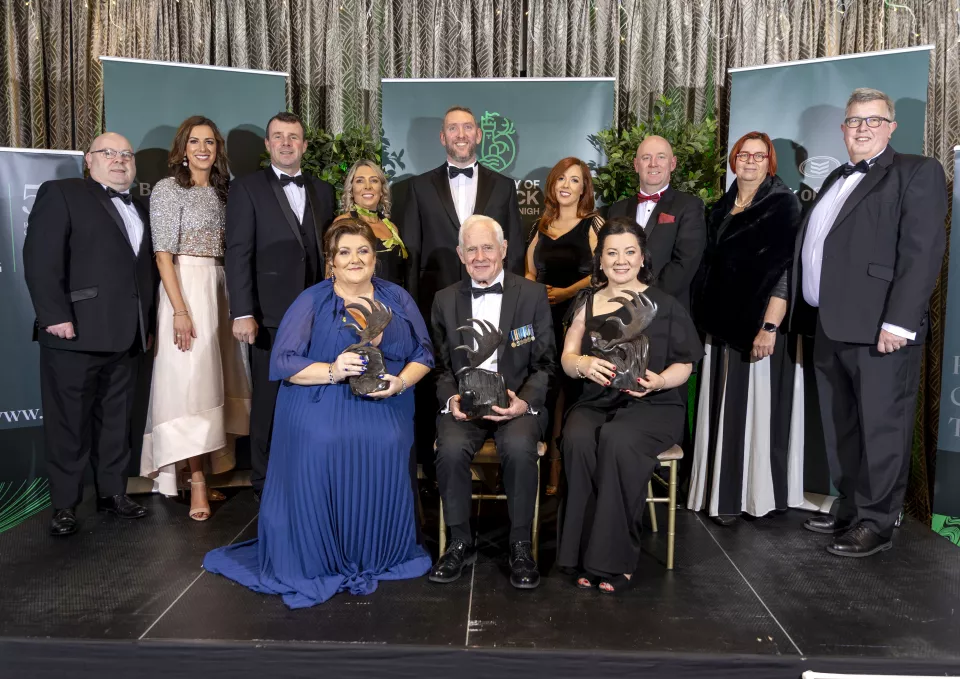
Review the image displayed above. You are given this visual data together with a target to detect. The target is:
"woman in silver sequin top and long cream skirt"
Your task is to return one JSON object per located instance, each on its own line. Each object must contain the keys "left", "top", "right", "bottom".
{"left": 140, "top": 116, "right": 250, "bottom": 521}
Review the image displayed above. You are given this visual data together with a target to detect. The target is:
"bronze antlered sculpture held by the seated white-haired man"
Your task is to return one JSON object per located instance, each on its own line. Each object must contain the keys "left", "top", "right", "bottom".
{"left": 456, "top": 318, "right": 510, "bottom": 420}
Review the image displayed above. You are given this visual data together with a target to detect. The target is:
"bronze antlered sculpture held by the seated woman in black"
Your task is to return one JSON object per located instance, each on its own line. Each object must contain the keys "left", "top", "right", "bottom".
{"left": 590, "top": 290, "right": 657, "bottom": 391}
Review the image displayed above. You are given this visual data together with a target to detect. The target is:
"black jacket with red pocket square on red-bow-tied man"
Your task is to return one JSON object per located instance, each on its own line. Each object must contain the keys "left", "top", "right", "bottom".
{"left": 607, "top": 186, "right": 707, "bottom": 311}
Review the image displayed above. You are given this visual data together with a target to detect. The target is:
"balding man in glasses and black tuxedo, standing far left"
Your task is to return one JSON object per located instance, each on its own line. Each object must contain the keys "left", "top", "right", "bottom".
{"left": 23, "top": 132, "right": 156, "bottom": 535}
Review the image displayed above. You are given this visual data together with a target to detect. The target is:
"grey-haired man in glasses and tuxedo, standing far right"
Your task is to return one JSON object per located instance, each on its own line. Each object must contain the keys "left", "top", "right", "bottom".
{"left": 792, "top": 89, "right": 947, "bottom": 557}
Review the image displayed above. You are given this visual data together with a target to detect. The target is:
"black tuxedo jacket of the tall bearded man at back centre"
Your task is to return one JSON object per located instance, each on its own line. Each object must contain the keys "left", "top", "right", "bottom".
{"left": 400, "top": 163, "right": 526, "bottom": 312}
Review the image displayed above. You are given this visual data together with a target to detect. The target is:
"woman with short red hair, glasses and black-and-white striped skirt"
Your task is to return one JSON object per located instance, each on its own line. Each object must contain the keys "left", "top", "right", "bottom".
{"left": 687, "top": 132, "right": 804, "bottom": 526}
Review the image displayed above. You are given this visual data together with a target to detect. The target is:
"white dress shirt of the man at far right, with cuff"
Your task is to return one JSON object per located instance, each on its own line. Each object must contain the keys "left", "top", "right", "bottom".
{"left": 800, "top": 148, "right": 917, "bottom": 340}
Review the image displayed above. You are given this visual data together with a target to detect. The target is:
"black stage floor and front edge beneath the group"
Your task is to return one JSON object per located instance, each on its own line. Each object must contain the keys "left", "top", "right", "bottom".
{"left": 0, "top": 490, "right": 960, "bottom": 679}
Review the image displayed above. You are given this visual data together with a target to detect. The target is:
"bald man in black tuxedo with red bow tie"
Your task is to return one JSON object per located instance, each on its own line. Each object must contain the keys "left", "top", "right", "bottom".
{"left": 607, "top": 135, "right": 707, "bottom": 311}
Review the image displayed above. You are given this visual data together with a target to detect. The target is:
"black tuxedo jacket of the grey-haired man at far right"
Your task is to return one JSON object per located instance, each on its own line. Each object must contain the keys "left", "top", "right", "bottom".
{"left": 791, "top": 146, "right": 947, "bottom": 344}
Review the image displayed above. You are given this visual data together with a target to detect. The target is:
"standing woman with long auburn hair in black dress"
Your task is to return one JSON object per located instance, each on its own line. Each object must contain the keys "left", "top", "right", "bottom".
{"left": 526, "top": 157, "right": 603, "bottom": 495}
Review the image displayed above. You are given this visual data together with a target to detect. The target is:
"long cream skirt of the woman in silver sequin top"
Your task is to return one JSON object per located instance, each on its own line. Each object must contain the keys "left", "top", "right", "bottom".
{"left": 140, "top": 255, "right": 250, "bottom": 495}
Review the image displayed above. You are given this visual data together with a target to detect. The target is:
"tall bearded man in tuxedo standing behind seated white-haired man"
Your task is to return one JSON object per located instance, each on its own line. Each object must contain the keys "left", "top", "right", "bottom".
{"left": 401, "top": 106, "right": 525, "bottom": 316}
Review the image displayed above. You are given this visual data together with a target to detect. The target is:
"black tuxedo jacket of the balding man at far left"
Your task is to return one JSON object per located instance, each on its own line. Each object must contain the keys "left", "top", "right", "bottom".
{"left": 23, "top": 178, "right": 157, "bottom": 352}
